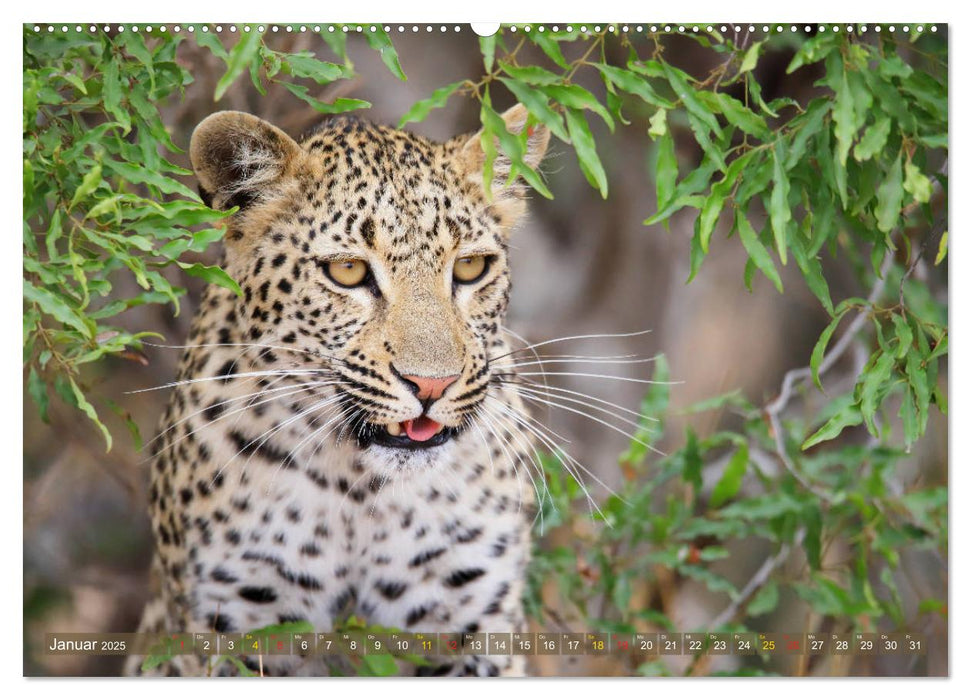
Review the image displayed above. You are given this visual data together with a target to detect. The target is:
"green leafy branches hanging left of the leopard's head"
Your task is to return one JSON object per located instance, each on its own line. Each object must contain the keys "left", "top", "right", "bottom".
{"left": 23, "top": 25, "right": 405, "bottom": 449}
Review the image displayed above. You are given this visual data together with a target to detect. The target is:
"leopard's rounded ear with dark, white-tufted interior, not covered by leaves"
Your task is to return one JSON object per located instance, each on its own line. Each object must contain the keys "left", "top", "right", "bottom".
{"left": 189, "top": 112, "right": 302, "bottom": 210}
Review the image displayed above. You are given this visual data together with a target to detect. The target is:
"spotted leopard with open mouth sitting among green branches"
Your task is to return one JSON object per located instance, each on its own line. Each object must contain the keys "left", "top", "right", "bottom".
{"left": 125, "top": 104, "right": 550, "bottom": 676}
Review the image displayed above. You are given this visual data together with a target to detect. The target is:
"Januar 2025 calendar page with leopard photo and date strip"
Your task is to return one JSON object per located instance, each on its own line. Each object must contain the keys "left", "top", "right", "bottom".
{"left": 22, "top": 20, "right": 950, "bottom": 680}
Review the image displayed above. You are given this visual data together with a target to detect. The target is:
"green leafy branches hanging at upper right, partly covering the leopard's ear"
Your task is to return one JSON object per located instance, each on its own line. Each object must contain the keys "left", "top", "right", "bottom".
{"left": 402, "top": 27, "right": 948, "bottom": 448}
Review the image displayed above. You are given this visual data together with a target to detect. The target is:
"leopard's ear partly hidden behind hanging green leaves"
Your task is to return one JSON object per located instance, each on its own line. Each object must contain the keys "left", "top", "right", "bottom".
{"left": 457, "top": 104, "right": 550, "bottom": 223}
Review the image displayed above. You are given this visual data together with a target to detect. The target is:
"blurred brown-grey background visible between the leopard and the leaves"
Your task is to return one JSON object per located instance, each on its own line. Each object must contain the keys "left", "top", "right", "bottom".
{"left": 23, "top": 26, "right": 947, "bottom": 675}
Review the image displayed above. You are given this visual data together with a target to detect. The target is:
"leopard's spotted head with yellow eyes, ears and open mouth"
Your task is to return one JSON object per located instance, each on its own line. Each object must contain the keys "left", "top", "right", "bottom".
{"left": 191, "top": 107, "right": 548, "bottom": 471}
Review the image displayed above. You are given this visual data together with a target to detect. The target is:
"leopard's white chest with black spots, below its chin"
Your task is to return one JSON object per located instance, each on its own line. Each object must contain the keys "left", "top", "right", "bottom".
{"left": 153, "top": 386, "right": 529, "bottom": 632}
